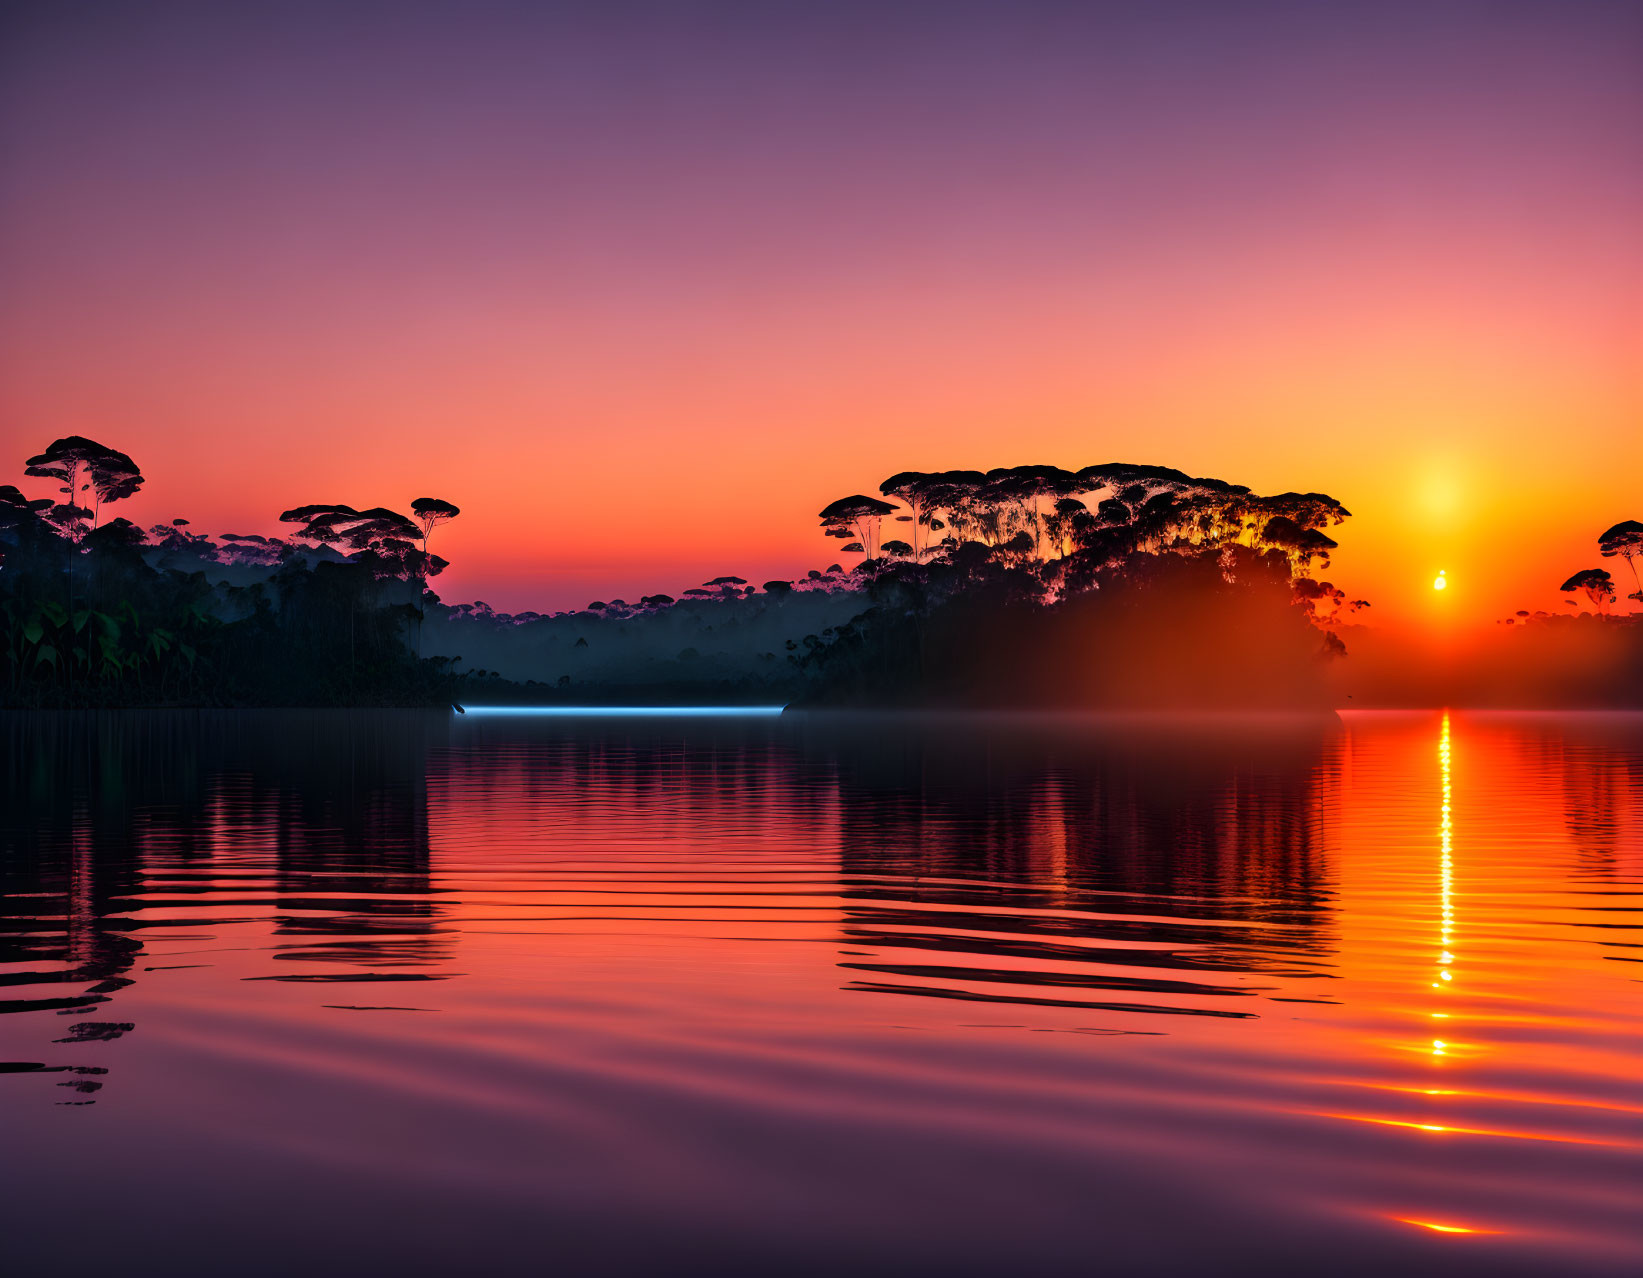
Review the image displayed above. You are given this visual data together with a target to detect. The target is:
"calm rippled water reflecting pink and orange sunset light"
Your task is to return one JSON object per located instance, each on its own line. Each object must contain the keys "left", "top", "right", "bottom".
{"left": 0, "top": 711, "right": 1643, "bottom": 1278}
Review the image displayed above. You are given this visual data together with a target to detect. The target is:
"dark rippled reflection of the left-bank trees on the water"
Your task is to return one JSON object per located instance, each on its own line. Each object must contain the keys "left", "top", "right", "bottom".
{"left": 0, "top": 711, "right": 445, "bottom": 1097}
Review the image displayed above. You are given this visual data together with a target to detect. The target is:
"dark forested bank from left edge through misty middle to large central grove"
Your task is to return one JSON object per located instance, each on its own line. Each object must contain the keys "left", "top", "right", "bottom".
{"left": 0, "top": 437, "right": 1362, "bottom": 706}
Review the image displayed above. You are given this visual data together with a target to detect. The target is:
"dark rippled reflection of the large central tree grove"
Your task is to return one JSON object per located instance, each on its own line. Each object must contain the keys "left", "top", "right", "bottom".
{"left": 801, "top": 721, "right": 1339, "bottom": 1015}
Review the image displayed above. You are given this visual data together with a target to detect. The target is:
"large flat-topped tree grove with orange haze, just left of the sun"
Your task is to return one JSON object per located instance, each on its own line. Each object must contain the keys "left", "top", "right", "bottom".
{"left": 800, "top": 463, "right": 1367, "bottom": 706}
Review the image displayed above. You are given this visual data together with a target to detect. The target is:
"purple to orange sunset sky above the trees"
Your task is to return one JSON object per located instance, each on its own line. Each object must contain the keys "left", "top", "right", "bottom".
{"left": 0, "top": 0, "right": 1643, "bottom": 631}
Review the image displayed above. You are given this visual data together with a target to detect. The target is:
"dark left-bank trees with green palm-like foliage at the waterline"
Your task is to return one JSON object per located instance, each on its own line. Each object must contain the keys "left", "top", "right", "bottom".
{"left": 0, "top": 435, "right": 460, "bottom": 706}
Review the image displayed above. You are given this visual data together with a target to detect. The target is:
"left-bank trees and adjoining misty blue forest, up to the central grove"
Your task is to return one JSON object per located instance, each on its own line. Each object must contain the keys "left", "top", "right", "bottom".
{"left": 0, "top": 435, "right": 861, "bottom": 706}
